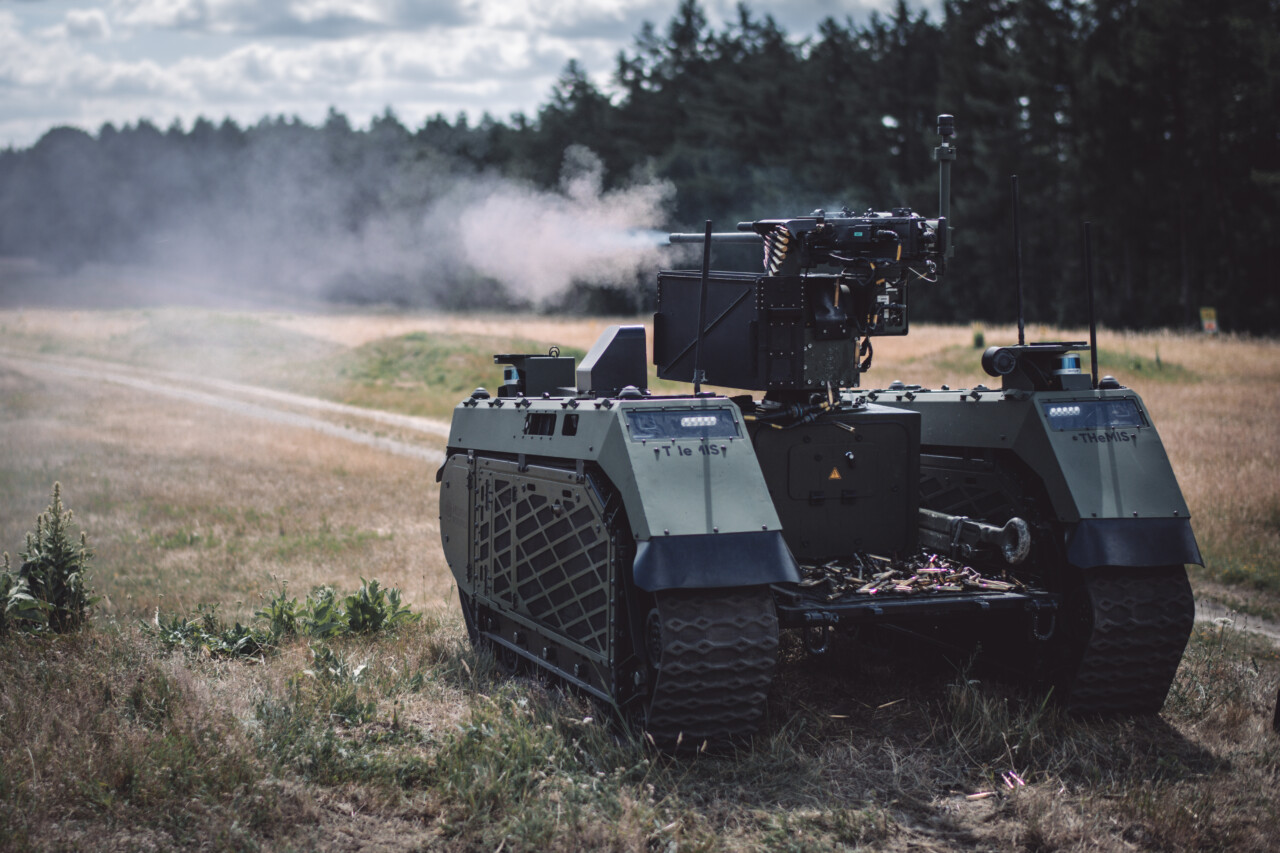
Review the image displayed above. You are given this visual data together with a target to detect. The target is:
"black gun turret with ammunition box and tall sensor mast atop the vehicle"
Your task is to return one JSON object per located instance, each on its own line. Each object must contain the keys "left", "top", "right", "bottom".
{"left": 654, "top": 115, "right": 955, "bottom": 392}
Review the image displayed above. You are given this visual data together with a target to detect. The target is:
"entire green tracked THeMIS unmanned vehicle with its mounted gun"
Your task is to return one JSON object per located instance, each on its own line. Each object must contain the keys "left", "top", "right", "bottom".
{"left": 436, "top": 115, "right": 1199, "bottom": 748}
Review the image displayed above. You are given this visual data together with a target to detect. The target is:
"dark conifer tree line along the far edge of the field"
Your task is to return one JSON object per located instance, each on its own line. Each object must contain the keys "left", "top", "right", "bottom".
{"left": 0, "top": 0, "right": 1280, "bottom": 333}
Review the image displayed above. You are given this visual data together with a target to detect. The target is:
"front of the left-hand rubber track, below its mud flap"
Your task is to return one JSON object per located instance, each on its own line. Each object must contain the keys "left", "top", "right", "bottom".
{"left": 645, "top": 589, "right": 778, "bottom": 748}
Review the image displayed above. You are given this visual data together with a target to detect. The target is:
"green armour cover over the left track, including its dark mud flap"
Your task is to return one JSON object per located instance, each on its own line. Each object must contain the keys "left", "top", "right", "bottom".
{"left": 440, "top": 397, "right": 799, "bottom": 590}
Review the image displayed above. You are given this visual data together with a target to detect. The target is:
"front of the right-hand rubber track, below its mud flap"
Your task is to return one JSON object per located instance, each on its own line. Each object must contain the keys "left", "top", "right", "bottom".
{"left": 1064, "top": 566, "right": 1196, "bottom": 715}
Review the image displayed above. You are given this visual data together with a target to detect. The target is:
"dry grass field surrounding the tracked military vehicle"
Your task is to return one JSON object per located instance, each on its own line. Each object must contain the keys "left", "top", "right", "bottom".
{"left": 0, "top": 309, "right": 1280, "bottom": 850}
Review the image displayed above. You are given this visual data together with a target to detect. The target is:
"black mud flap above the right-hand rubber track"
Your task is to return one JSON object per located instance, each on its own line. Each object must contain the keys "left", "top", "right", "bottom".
{"left": 1066, "top": 519, "right": 1204, "bottom": 569}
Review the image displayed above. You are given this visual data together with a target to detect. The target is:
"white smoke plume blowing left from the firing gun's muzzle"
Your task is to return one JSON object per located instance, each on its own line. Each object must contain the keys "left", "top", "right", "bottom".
{"left": 0, "top": 136, "right": 675, "bottom": 309}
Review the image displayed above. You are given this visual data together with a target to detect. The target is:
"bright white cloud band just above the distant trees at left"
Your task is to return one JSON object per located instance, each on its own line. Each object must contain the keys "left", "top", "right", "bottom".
{"left": 0, "top": 8, "right": 575, "bottom": 147}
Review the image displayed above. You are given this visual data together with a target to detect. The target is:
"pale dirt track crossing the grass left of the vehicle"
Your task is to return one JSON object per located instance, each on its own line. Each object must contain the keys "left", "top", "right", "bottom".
{"left": 0, "top": 352, "right": 449, "bottom": 464}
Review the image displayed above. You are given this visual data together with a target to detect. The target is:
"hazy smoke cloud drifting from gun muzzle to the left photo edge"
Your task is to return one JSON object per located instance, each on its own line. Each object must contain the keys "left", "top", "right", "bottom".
{"left": 0, "top": 124, "right": 675, "bottom": 309}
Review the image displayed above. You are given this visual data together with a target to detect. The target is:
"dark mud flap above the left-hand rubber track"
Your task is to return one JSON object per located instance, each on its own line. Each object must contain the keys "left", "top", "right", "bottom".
{"left": 634, "top": 530, "right": 800, "bottom": 592}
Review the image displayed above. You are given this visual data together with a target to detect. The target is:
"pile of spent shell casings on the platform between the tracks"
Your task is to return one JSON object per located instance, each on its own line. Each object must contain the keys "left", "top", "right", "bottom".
{"left": 800, "top": 553, "right": 1024, "bottom": 601}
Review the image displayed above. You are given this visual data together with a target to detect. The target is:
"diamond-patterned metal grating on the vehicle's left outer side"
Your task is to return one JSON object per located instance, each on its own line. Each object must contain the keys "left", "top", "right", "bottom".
{"left": 476, "top": 461, "right": 612, "bottom": 654}
